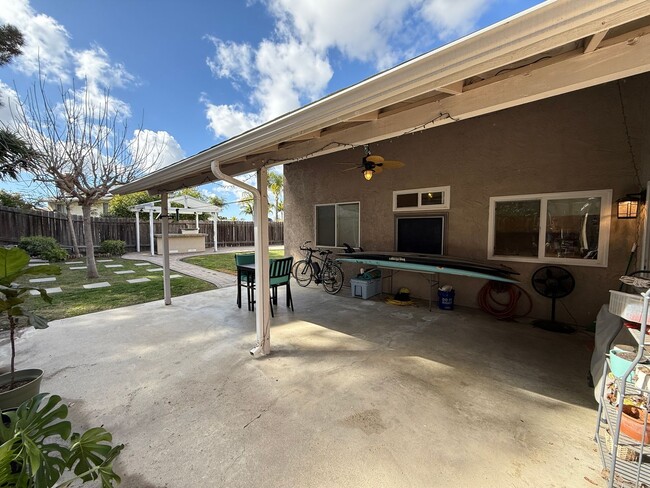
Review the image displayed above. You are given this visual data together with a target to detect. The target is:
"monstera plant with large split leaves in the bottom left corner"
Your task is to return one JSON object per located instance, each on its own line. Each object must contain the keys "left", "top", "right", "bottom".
{"left": 0, "top": 393, "right": 124, "bottom": 488}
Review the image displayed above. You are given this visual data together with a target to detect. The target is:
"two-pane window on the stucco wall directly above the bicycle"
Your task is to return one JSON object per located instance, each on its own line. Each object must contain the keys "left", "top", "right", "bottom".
{"left": 315, "top": 202, "right": 360, "bottom": 247}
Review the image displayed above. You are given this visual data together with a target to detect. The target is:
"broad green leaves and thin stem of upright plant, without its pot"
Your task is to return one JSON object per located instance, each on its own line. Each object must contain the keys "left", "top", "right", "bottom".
{"left": 0, "top": 247, "right": 61, "bottom": 388}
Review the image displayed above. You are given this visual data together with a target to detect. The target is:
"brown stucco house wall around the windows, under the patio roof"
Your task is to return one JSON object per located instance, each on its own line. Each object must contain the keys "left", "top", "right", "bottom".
{"left": 284, "top": 74, "right": 650, "bottom": 324}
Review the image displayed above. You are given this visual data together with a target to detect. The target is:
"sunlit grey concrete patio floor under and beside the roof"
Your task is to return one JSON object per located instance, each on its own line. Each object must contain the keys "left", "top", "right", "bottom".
{"left": 11, "top": 286, "right": 605, "bottom": 488}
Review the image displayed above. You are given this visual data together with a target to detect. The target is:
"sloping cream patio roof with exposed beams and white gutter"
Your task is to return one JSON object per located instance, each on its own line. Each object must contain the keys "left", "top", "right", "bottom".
{"left": 114, "top": 0, "right": 650, "bottom": 194}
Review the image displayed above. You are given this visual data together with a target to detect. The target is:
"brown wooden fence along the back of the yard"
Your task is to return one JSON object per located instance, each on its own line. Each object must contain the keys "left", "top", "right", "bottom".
{"left": 0, "top": 206, "right": 284, "bottom": 251}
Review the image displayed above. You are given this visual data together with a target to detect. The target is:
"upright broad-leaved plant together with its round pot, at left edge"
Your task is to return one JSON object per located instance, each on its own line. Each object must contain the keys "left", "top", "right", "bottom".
{"left": 0, "top": 248, "right": 61, "bottom": 409}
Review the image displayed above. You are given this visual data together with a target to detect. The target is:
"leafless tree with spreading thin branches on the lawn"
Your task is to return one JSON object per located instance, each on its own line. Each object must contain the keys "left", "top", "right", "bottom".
{"left": 13, "top": 79, "right": 160, "bottom": 278}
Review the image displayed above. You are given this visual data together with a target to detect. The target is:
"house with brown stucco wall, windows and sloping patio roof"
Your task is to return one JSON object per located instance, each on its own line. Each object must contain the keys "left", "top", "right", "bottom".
{"left": 117, "top": 0, "right": 650, "bottom": 326}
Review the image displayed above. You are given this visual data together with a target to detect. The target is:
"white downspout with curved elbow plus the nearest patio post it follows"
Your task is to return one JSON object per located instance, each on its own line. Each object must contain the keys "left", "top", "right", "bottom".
{"left": 210, "top": 161, "right": 271, "bottom": 357}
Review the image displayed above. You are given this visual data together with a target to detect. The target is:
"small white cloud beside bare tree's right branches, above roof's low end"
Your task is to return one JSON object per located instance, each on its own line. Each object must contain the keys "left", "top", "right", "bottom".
{"left": 130, "top": 129, "right": 185, "bottom": 171}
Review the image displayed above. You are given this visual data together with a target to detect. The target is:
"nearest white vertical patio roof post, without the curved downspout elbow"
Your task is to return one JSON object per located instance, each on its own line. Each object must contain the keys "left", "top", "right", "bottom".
{"left": 253, "top": 167, "right": 271, "bottom": 355}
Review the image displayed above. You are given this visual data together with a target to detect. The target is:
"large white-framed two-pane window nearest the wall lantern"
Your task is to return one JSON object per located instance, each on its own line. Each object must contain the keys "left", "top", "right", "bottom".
{"left": 488, "top": 190, "right": 612, "bottom": 266}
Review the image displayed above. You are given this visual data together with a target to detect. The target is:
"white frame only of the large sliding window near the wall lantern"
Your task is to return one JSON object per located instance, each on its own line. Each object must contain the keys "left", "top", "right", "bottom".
{"left": 487, "top": 190, "right": 612, "bottom": 267}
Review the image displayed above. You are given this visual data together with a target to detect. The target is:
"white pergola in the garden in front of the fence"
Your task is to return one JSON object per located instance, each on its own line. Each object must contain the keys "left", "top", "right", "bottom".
{"left": 129, "top": 195, "right": 221, "bottom": 256}
